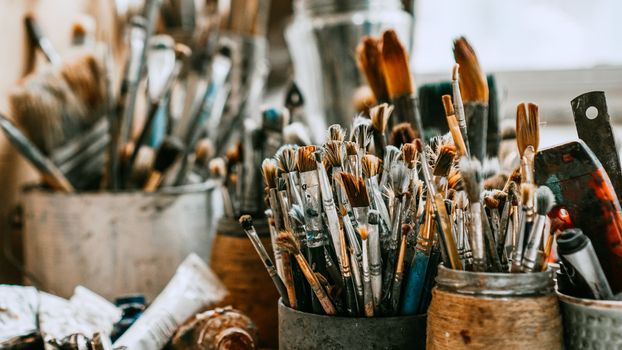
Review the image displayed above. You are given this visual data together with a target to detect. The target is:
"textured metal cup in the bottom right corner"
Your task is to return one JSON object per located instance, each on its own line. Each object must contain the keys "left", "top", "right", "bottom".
{"left": 557, "top": 292, "right": 622, "bottom": 350}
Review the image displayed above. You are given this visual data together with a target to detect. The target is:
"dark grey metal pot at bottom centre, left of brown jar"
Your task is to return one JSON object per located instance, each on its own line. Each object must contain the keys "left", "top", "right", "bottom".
{"left": 279, "top": 300, "right": 426, "bottom": 350}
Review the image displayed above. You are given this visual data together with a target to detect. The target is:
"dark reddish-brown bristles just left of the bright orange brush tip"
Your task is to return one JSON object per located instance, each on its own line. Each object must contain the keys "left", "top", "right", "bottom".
{"left": 356, "top": 36, "right": 389, "bottom": 101}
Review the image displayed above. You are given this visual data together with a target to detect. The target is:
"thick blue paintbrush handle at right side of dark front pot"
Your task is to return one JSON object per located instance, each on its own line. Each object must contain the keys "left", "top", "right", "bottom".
{"left": 400, "top": 249, "right": 430, "bottom": 315}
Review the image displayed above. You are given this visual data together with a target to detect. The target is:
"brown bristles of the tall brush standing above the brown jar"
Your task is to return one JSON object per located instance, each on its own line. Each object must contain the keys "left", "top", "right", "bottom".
{"left": 454, "top": 37, "right": 488, "bottom": 104}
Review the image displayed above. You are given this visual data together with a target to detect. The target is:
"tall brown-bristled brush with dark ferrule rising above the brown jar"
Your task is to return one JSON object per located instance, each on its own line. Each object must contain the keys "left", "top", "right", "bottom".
{"left": 453, "top": 37, "right": 488, "bottom": 161}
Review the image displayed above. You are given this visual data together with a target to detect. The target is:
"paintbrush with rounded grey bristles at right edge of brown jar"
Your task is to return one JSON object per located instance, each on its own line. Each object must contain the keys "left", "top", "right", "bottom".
{"left": 522, "top": 186, "right": 555, "bottom": 272}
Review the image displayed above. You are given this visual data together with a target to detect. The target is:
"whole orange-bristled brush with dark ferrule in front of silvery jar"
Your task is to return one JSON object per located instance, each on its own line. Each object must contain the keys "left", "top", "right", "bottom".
{"left": 382, "top": 30, "right": 423, "bottom": 138}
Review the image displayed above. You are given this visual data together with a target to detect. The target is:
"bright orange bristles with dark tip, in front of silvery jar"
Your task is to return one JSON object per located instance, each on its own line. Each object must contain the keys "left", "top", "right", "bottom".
{"left": 382, "top": 30, "right": 415, "bottom": 99}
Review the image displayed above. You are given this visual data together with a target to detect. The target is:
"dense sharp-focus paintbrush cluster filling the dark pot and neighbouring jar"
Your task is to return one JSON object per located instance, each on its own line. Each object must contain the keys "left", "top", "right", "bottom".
{"left": 240, "top": 95, "right": 554, "bottom": 317}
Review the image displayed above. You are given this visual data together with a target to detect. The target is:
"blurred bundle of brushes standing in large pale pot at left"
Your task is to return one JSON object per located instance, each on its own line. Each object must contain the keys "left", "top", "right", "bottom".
{"left": 0, "top": 0, "right": 268, "bottom": 192}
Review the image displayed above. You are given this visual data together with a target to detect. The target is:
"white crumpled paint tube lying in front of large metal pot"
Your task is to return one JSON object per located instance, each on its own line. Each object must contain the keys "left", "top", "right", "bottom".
{"left": 114, "top": 254, "right": 227, "bottom": 350}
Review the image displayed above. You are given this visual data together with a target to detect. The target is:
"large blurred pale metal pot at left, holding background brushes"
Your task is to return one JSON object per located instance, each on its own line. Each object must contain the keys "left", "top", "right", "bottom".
{"left": 23, "top": 183, "right": 218, "bottom": 300}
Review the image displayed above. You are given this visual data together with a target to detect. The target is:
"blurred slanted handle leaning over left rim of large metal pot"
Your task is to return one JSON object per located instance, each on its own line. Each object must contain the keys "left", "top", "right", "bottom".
{"left": 0, "top": 114, "right": 74, "bottom": 192}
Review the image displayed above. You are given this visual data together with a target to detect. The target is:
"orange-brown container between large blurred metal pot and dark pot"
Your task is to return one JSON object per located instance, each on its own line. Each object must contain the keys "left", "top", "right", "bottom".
{"left": 211, "top": 217, "right": 279, "bottom": 349}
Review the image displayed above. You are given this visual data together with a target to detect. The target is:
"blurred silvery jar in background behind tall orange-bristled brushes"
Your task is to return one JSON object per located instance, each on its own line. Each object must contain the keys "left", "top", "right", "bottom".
{"left": 285, "top": 0, "right": 414, "bottom": 140}
